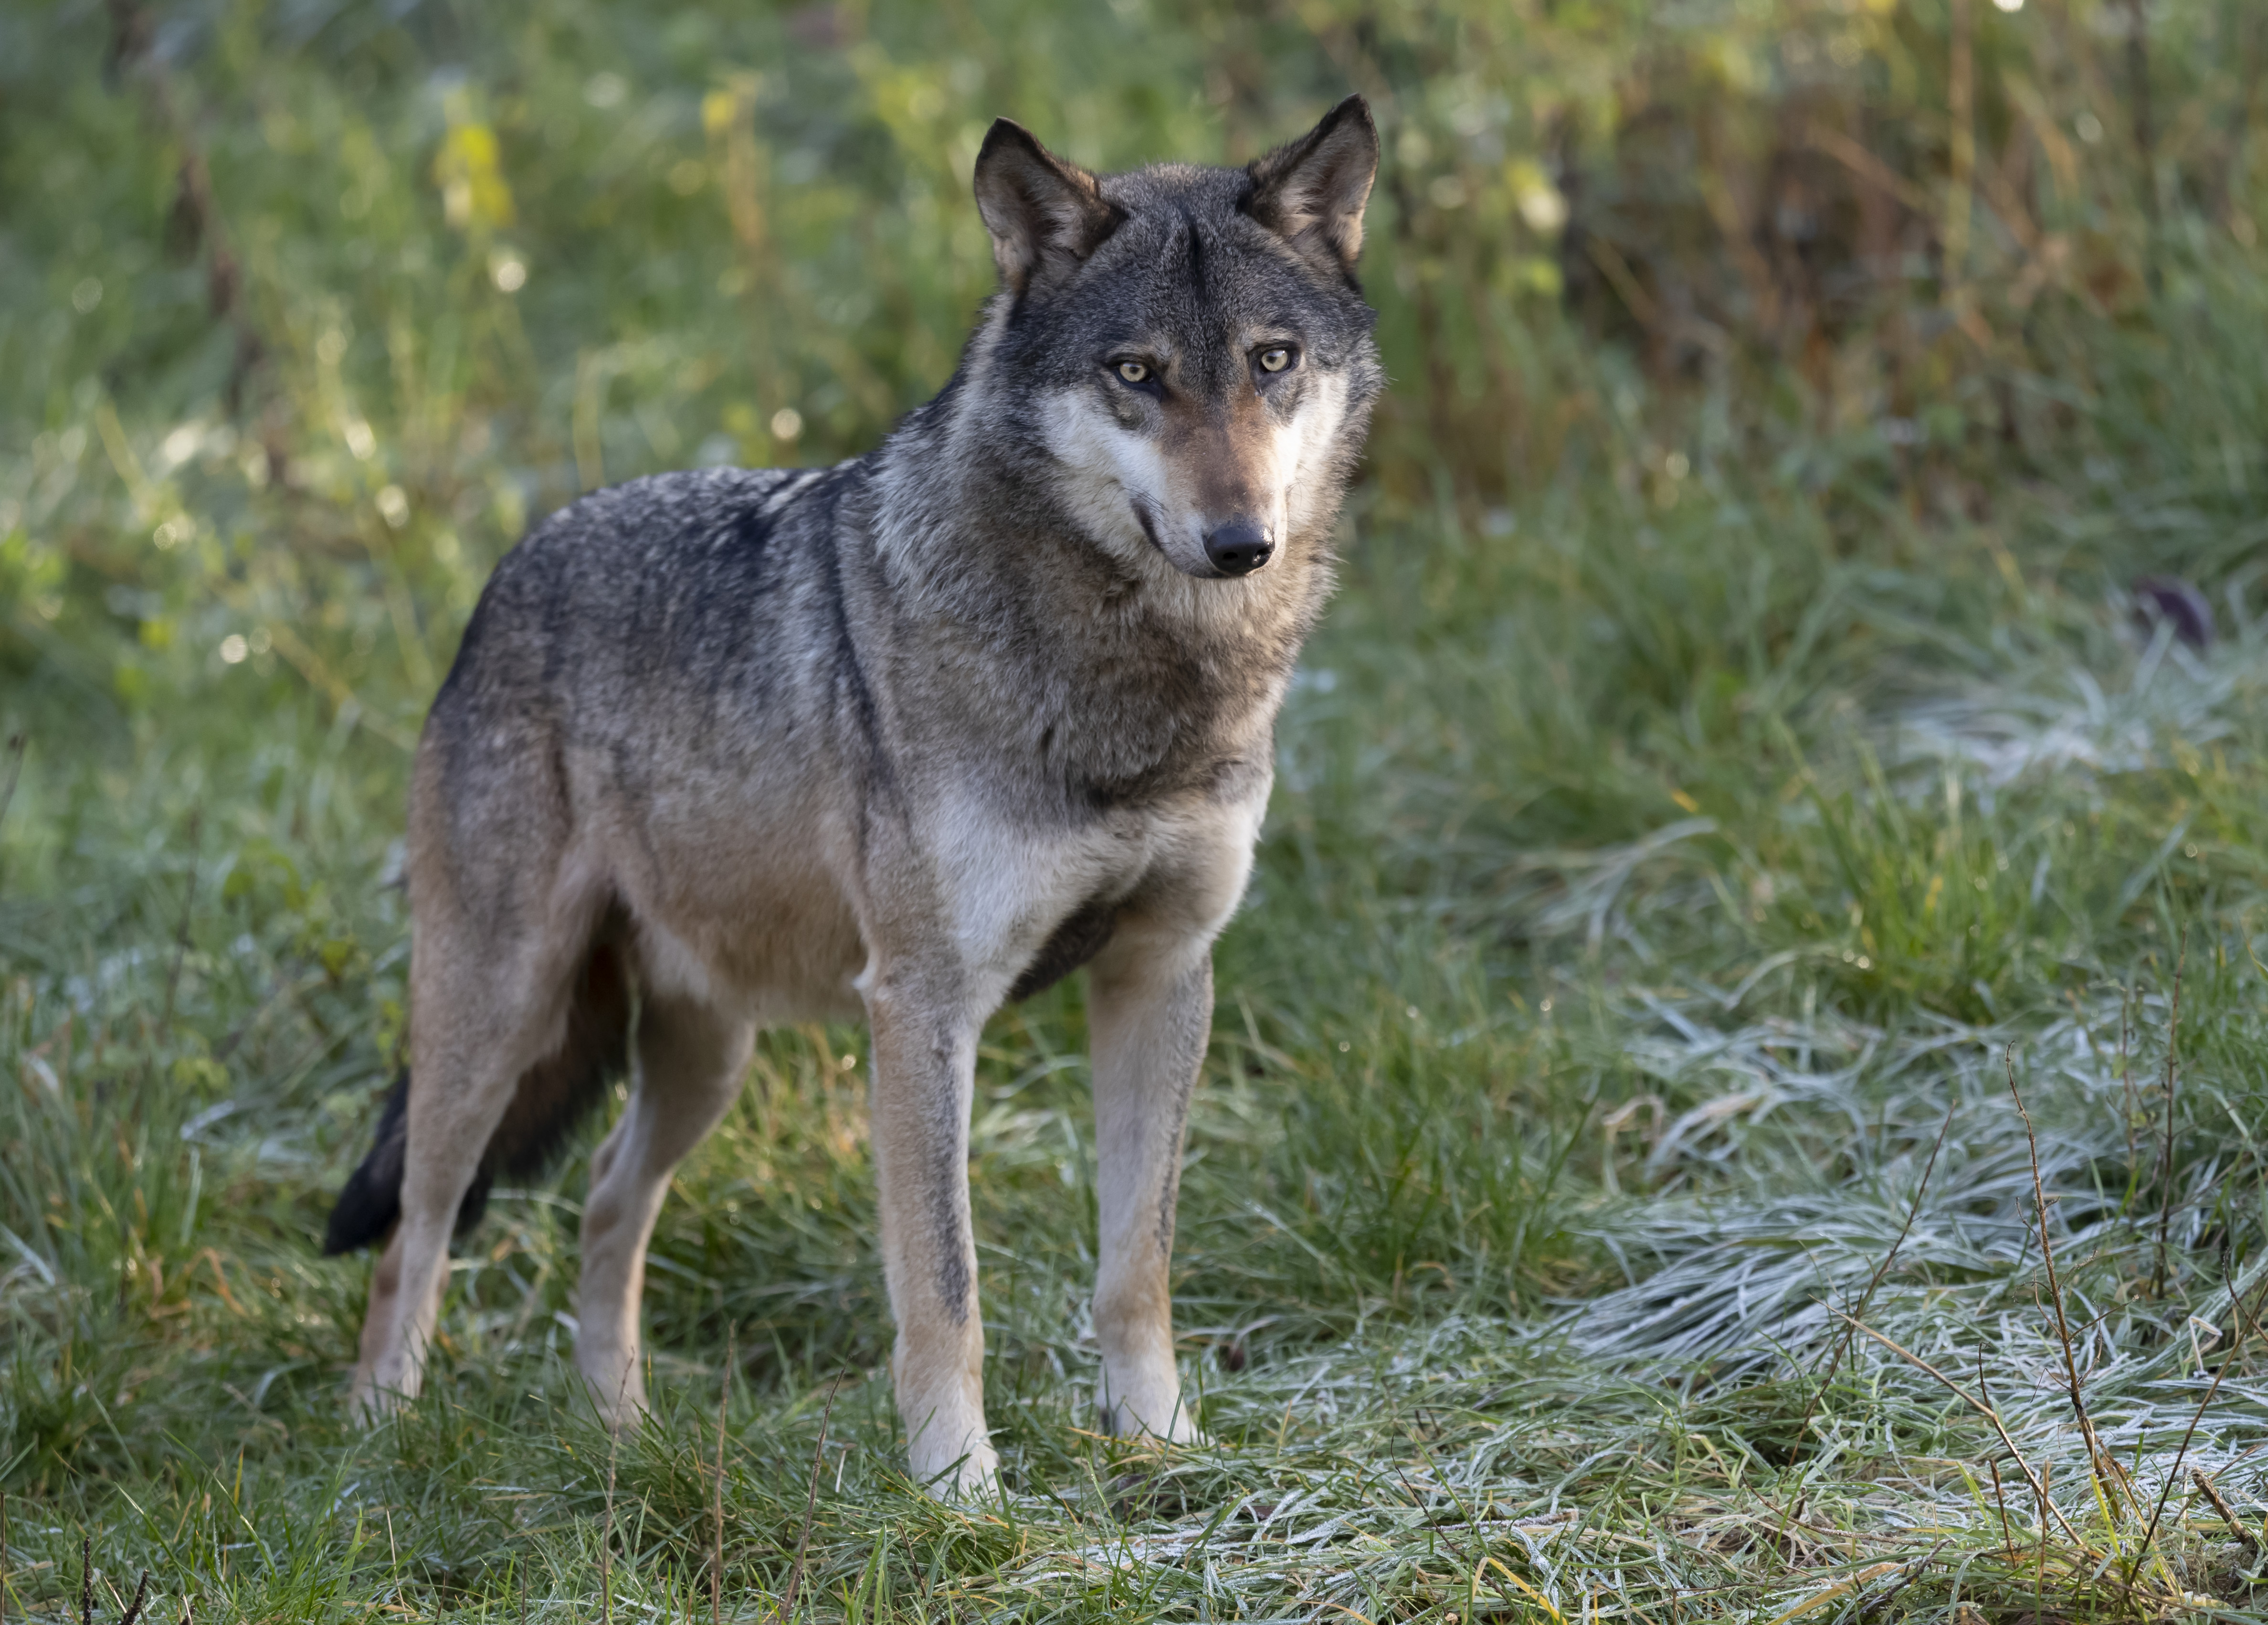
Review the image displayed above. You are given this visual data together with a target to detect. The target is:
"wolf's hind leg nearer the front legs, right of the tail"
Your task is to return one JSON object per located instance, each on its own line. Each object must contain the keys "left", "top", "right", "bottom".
{"left": 574, "top": 994, "right": 755, "bottom": 1428}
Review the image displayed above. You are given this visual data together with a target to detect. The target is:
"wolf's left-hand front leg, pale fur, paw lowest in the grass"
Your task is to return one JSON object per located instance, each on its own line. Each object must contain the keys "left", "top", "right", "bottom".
{"left": 866, "top": 969, "right": 998, "bottom": 1496}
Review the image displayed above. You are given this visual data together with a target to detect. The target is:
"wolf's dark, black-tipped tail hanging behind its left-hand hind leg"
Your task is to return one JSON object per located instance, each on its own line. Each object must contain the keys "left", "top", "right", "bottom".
{"left": 322, "top": 942, "right": 631, "bottom": 1257}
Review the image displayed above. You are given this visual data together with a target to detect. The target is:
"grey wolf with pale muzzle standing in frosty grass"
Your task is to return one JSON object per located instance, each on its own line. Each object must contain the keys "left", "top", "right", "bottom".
{"left": 324, "top": 97, "right": 1383, "bottom": 1496}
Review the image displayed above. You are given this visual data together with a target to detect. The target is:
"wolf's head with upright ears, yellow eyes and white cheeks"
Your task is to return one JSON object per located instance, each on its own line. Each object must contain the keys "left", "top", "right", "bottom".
{"left": 975, "top": 96, "right": 1383, "bottom": 579}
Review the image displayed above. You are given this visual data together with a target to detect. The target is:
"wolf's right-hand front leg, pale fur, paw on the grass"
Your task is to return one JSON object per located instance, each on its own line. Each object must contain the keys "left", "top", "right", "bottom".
{"left": 1087, "top": 922, "right": 1213, "bottom": 1441}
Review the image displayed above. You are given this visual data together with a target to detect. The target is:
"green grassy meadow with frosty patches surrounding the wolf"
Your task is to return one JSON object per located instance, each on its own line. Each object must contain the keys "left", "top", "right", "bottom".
{"left": 0, "top": 0, "right": 2268, "bottom": 1625}
